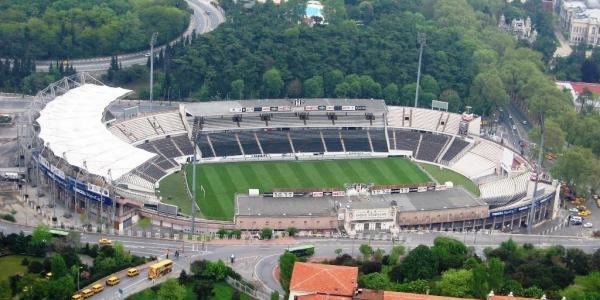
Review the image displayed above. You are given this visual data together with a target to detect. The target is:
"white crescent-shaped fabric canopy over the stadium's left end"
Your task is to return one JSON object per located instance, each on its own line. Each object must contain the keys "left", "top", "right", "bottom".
{"left": 37, "top": 84, "right": 156, "bottom": 180}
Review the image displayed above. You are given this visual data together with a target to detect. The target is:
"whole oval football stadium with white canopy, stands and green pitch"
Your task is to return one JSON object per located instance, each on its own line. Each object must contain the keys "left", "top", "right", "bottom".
{"left": 21, "top": 74, "right": 559, "bottom": 235}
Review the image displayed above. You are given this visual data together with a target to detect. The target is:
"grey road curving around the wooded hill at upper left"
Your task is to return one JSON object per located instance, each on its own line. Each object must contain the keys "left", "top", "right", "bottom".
{"left": 36, "top": 0, "right": 225, "bottom": 72}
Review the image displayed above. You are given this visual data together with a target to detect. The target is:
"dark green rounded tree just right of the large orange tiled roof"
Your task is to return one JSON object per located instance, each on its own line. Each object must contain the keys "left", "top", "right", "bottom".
{"left": 389, "top": 245, "right": 438, "bottom": 282}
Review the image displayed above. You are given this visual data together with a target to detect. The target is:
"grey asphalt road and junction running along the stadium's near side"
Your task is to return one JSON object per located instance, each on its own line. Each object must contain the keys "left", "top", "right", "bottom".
{"left": 0, "top": 222, "right": 600, "bottom": 299}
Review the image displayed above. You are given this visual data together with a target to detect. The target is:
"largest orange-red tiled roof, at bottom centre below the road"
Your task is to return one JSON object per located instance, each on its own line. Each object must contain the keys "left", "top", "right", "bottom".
{"left": 290, "top": 262, "right": 358, "bottom": 297}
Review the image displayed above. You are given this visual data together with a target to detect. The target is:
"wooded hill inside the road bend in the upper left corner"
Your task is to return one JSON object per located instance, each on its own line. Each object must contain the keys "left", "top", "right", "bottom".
{"left": 0, "top": 0, "right": 189, "bottom": 60}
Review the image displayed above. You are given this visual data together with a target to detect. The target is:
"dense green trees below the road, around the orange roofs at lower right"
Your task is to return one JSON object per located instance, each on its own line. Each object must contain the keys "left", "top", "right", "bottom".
{"left": 279, "top": 237, "right": 600, "bottom": 300}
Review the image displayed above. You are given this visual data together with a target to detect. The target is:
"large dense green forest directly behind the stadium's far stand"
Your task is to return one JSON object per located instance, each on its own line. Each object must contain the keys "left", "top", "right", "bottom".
{"left": 129, "top": 0, "right": 562, "bottom": 114}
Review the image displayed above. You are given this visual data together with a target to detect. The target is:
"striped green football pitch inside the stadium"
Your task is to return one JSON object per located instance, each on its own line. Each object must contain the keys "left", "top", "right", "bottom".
{"left": 160, "top": 158, "right": 433, "bottom": 220}
